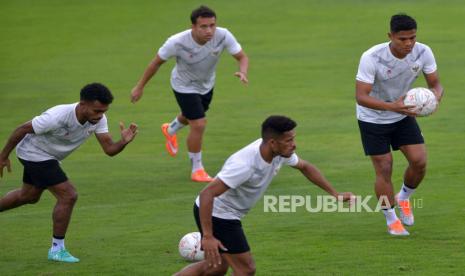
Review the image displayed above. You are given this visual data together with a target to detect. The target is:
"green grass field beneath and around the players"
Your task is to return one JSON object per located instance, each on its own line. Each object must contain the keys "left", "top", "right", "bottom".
{"left": 0, "top": 0, "right": 465, "bottom": 275}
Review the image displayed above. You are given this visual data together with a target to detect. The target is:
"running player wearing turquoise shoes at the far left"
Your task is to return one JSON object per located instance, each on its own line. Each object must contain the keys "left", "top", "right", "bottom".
{"left": 0, "top": 83, "right": 137, "bottom": 263}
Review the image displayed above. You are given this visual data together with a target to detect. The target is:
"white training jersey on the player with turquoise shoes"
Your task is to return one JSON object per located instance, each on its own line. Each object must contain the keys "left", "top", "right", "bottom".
{"left": 16, "top": 103, "right": 108, "bottom": 162}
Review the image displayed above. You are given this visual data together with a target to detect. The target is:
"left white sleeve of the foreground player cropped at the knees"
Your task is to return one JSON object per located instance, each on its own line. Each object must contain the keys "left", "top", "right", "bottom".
{"left": 216, "top": 159, "right": 253, "bottom": 189}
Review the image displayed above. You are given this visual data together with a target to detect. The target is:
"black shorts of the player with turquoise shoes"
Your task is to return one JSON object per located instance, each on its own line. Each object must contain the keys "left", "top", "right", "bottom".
{"left": 18, "top": 158, "right": 68, "bottom": 189}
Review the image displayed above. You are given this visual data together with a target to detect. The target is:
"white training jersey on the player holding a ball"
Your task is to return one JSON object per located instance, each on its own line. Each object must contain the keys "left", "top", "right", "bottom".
{"left": 356, "top": 42, "right": 437, "bottom": 124}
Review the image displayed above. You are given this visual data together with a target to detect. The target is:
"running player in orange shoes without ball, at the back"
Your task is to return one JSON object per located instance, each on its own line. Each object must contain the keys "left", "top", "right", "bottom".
{"left": 131, "top": 6, "right": 249, "bottom": 182}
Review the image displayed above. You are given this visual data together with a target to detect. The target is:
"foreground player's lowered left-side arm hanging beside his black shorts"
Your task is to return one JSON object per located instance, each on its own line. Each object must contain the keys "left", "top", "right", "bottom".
{"left": 199, "top": 178, "right": 229, "bottom": 267}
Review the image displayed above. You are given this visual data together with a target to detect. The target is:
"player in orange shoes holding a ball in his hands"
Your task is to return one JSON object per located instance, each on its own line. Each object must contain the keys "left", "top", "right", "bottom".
{"left": 355, "top": 14, "right": 443, "bottom": 235}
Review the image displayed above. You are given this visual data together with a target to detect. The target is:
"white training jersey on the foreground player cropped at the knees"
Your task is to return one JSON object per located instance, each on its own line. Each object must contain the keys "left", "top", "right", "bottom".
{"left": 196, "top": 139, "right": 299, "bottom": 219}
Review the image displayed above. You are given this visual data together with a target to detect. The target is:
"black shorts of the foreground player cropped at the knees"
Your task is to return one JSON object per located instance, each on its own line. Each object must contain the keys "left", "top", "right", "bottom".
{"left": 194, "top": 203, "right": 250, "bottom": 254}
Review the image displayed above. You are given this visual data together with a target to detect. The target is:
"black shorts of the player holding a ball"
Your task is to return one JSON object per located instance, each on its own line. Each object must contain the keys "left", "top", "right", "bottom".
{"left": 358, "top": 116, "right": 425, "bottom": 155}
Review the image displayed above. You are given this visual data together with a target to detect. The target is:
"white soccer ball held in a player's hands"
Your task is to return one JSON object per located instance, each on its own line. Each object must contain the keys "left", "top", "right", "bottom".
{"left": 404, "top": 87, "right": 438, "bottom": 117}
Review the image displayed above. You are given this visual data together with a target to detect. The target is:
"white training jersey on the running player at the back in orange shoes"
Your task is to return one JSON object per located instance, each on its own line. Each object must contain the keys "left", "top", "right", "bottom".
{"left": 158, "top": 27, "right": 242, "bottom": 94}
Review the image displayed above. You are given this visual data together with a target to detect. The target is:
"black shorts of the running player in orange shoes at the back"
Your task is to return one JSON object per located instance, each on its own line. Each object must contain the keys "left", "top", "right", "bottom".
{"left": 173, "top": 88, "right": 213, "bottom": 120}
